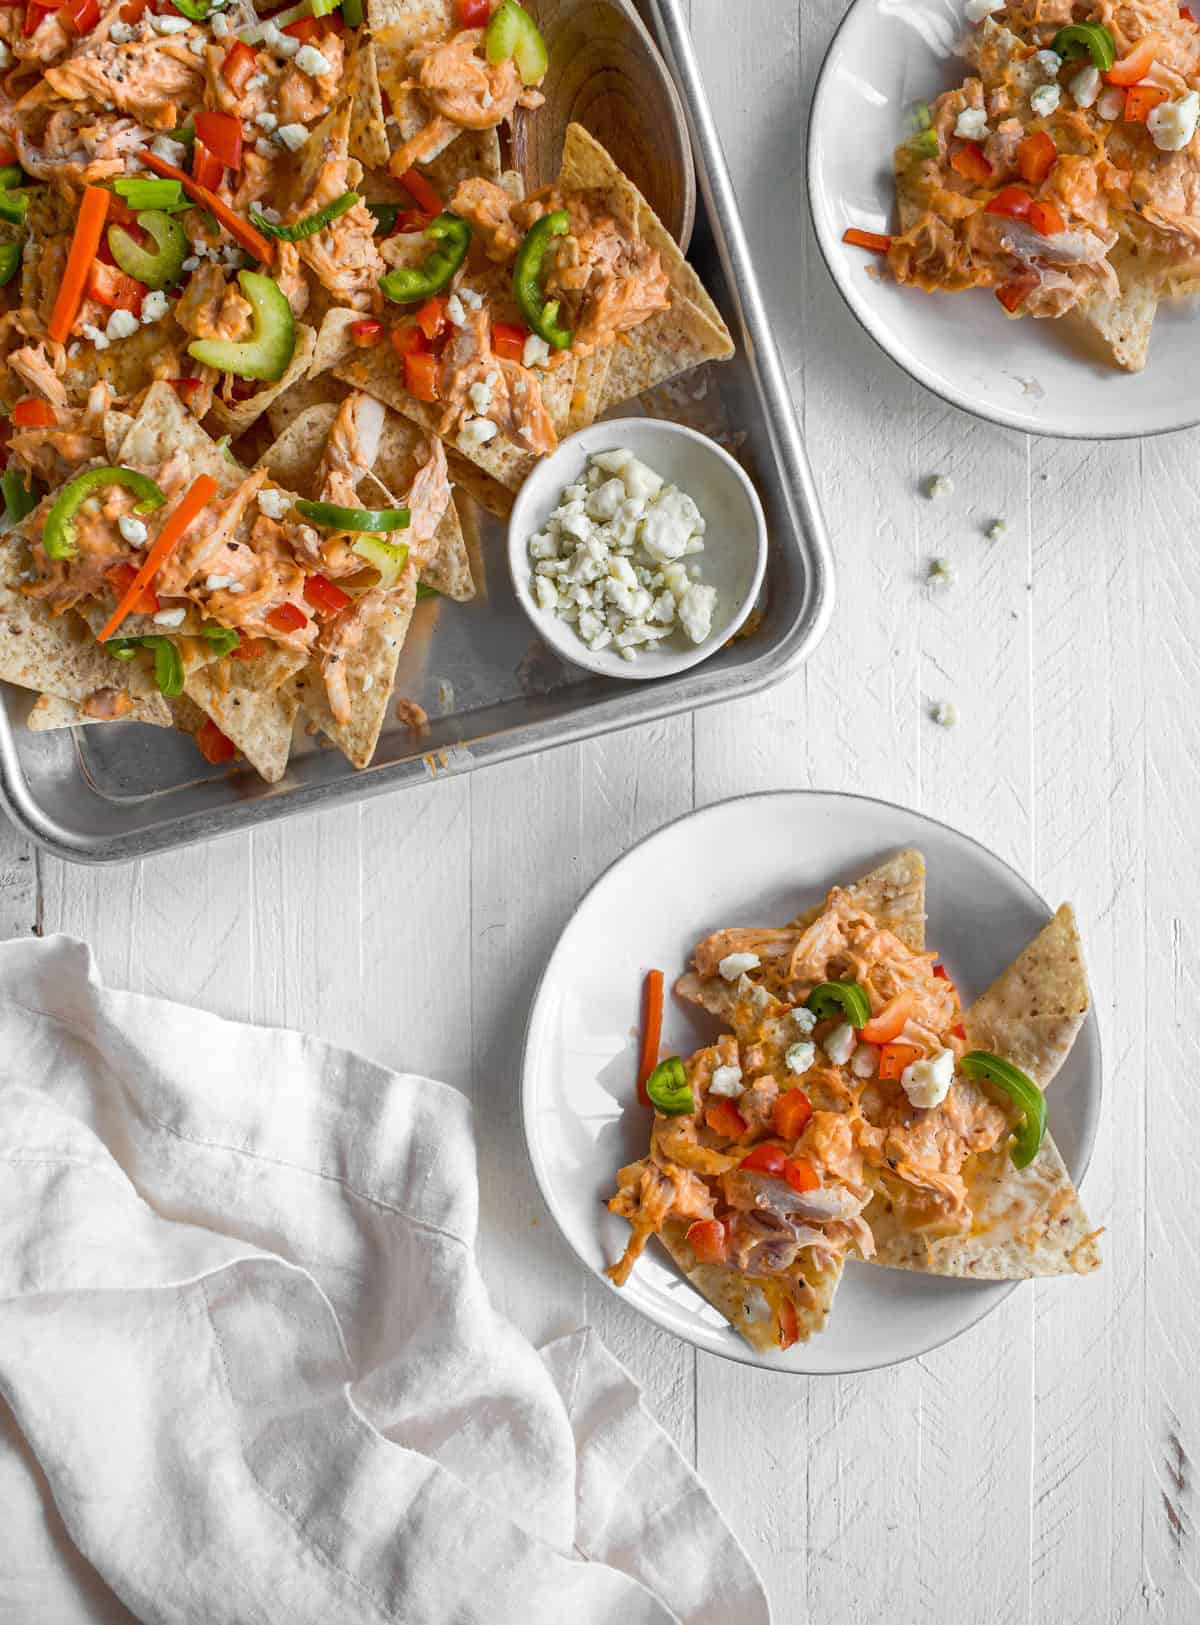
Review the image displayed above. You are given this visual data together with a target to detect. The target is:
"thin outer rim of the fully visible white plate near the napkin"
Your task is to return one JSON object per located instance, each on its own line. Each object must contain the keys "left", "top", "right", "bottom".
{"left": 520, "top": 787, "right": 1104, "bottom": 1378}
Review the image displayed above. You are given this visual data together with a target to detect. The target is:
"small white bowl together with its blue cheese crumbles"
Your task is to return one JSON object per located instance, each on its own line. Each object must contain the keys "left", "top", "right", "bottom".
{"left": 509, "top": 418, "right": 766, "bottom": 678}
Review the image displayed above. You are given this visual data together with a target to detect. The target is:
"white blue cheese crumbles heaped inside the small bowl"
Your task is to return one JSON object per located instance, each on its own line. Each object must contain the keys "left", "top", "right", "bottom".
{"left": 528, "top": 447, "right": 717, "bottom": 660}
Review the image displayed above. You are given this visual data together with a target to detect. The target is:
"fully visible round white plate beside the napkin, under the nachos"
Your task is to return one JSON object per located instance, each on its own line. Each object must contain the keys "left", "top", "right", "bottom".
{"left": 522, "top": 791, "right": 1101, "bottom": 1373}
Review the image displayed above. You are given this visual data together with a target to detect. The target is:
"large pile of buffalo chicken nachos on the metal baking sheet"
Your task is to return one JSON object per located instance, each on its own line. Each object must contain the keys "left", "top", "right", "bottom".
{"left": 0, "top": 0, "right": 732, "bottom": 780}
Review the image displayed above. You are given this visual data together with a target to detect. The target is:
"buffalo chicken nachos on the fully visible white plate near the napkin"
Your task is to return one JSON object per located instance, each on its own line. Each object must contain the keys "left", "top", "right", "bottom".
{"left": 608, "top": 852, "right": 1099, "bottom": 1349}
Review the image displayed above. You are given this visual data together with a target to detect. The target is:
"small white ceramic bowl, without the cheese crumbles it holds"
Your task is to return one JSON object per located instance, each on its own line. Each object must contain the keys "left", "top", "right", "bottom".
{"left": 509, "top": 418, "right": 767, "bottom": 683}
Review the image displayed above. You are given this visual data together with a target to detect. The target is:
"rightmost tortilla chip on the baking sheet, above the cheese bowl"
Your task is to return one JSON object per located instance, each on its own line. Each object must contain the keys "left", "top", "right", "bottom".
{"left": 558, "top": 124, "right": 733, "bottom": 411}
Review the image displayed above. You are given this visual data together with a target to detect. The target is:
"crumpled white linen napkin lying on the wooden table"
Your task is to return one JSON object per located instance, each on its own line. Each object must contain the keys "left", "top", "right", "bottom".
{"left": 0, "top": 938, "right": 769, "bottom": 1625}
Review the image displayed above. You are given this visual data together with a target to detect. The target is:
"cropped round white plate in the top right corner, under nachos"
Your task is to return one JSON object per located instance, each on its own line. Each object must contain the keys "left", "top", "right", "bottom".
{"left": 808, "top": 0, "right": 1200, "bottom": 440}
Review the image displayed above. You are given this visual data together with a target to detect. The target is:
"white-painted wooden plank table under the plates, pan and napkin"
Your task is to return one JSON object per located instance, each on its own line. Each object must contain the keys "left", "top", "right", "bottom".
{"left": 0, "top": 0, "right": 1200, "bottom": 1625}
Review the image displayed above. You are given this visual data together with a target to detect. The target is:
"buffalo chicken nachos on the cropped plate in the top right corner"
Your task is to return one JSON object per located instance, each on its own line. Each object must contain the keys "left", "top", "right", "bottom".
{"left": 846, "top": 0, "right": 1200, "bottom": 371}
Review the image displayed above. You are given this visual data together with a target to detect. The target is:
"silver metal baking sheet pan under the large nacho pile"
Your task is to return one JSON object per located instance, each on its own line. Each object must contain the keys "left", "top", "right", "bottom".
{"left": 0, "top": 0, "right": 833, "bottom": 863}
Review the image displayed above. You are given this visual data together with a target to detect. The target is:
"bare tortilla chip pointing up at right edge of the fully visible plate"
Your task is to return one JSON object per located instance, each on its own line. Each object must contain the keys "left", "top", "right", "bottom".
{"left": 964, "top": 904, "right": 1091, "bottom": 1089}
